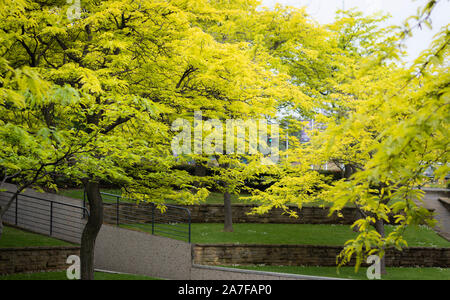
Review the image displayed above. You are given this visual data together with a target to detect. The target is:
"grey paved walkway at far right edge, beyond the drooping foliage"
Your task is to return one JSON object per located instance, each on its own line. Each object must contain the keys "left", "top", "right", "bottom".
{"left": 423, "top": 189, "right": 450, "bottom": 241}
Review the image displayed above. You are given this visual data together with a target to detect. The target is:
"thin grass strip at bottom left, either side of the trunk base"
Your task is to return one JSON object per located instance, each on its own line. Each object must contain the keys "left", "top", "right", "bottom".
{"left": 0, "top": 271, "right": 159, "bottom": 280}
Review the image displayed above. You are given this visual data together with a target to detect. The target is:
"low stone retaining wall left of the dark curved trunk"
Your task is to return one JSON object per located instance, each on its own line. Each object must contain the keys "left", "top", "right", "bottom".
{"left": 0, "top": 246, "right": 80, "bottom": 274}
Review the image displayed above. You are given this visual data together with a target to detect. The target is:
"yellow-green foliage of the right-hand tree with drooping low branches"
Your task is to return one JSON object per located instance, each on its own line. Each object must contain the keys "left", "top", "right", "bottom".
{"left": 244, "top": 1, "right": 449, "bottom": 274}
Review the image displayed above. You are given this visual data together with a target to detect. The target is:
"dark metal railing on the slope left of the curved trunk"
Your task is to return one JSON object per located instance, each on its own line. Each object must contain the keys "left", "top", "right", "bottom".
{"left": 0, "top": 191, "right": 89, "bottom": 242}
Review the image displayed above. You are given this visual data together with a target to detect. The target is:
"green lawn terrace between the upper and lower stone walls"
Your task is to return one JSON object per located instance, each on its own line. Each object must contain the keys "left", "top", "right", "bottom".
{"left": 123, "top": 223, "right": 450, "bottom": 247}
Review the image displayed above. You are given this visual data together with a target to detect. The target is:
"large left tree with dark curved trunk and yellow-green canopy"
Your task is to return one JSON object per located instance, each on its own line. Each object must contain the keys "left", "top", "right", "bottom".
{"left": 0, "top": 0, "right": 306, "bottom": 279}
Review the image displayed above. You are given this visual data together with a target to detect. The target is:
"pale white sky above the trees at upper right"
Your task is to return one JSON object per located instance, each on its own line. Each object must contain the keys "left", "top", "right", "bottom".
{"left": 262, "top": 0, "right": 450, "bottom": 61}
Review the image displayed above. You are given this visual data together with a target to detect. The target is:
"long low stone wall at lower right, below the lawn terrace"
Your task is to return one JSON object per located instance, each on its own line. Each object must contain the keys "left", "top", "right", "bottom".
{"left": 193, "top": 244, "right": 450, "bottom": 268}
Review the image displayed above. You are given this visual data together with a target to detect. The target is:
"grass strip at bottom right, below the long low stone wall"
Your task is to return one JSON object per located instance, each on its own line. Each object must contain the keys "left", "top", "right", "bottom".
{"left": 229, "top": 266, "right": 450, "bottom": 280}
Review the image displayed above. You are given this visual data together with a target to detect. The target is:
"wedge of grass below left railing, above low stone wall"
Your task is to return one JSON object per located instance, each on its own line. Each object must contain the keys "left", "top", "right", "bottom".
{"left": 0, "top": 226, "right": 73, "bottom": 248}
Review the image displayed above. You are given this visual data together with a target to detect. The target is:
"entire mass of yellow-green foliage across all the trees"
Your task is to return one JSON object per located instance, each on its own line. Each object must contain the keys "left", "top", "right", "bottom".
{"left": 0, "top": 0, "right": 450, "bottom": 270}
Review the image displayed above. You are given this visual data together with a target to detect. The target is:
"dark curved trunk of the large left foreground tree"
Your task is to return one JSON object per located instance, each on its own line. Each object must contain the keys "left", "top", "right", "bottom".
{"left": 80, "top": 182, "right": 103, "bottom": 280}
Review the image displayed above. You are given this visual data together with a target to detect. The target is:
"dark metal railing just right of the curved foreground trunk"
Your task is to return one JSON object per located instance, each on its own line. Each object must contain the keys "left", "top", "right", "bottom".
{"left": 83, "top": 192, "right": 191, "bottom": 243}
